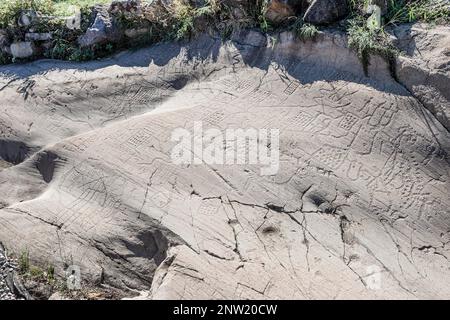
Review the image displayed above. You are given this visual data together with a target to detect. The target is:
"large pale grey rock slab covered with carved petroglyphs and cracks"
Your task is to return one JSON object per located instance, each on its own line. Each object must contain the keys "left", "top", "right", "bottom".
{"left": 0, "top": 26, "right": 450, "bottom": 299}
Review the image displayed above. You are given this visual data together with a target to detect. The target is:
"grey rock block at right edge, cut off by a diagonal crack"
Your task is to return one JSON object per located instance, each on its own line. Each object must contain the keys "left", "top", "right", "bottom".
{"left": 392, "top": 24, "right": 450, "bottom": 130}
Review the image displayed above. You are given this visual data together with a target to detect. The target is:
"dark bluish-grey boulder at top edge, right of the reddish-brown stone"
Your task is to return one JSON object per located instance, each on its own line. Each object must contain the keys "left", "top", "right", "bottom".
{"left": 303, "top": 0, "right": 348, "bottom": 24}
